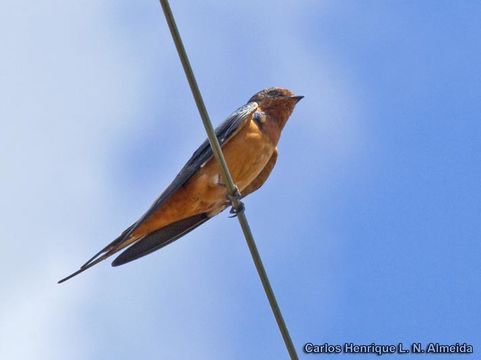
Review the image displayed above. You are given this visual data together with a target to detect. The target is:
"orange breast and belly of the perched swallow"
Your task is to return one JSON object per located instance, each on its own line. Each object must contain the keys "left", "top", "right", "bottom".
{"left": 131, "top": 121, "right": 275, "bottom": 239}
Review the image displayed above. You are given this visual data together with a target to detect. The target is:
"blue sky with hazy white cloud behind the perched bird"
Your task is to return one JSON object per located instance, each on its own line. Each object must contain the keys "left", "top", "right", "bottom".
{"left": 0, "top": 1, "right": 481, "bottom": 359}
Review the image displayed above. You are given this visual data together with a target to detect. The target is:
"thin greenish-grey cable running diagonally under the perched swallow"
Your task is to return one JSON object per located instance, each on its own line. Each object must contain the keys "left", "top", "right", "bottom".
{"left": 160, "top": 0, "right": 298, "bottom": 360}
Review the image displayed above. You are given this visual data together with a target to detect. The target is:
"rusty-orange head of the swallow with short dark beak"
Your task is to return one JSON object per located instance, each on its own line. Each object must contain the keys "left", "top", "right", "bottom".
{"left": 248, "top": 87, "right": 304, "bottom": 128}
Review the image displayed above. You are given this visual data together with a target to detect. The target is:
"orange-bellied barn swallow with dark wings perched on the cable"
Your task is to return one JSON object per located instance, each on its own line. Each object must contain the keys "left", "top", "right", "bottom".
{"left": 59, "top": 87, "right": 303, "bottom": 283}
